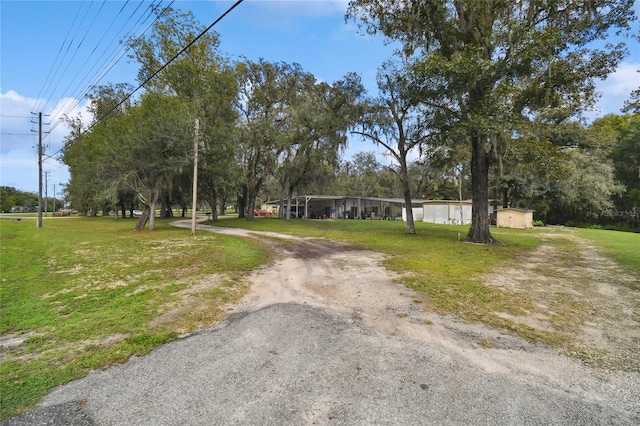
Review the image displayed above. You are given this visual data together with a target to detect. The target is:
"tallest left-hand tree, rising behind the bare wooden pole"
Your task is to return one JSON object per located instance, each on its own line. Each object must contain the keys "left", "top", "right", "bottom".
{"left": 128, "top": 8, "right": 237, "bottom": 223}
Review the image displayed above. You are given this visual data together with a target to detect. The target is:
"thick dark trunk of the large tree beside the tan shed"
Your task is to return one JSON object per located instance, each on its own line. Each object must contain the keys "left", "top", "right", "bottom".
{"left": 467, "top": 134, "right": 496, "bottom": 244}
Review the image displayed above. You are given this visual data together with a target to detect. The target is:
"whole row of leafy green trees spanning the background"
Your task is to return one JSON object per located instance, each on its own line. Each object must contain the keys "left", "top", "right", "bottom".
{"left": 62, "top": 4, "right": 639, "bottom": 236}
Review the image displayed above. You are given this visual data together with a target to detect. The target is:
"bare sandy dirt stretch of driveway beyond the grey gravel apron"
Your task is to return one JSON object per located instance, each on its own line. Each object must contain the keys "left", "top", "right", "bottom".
{"left": 172, "top": 223, "right": 637, "bottom": 383}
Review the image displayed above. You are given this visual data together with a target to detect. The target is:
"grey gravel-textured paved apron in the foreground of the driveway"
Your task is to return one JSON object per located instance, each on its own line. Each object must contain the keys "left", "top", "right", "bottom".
{"left": 7, "top": 304, "right": 640, "bottom": 425}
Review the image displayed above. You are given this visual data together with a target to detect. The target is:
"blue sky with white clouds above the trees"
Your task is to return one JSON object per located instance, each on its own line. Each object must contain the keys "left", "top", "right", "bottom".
{"left": 0, "top": 0, "right": 640, "bottom": 196}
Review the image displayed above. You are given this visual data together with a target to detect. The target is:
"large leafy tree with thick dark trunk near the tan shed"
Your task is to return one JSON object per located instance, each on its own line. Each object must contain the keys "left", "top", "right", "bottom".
{"left": 348, "top": 0, "right": 634, "bottom": 244}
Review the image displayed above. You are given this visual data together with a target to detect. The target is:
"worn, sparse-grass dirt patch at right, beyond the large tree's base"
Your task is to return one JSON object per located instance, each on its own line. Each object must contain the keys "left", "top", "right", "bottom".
{"left": 483, "top": 230, "right": 640, "bottom": 372}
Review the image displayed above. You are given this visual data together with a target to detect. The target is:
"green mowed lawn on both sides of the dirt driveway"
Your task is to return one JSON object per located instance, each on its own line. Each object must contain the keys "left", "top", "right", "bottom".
{"left": 0, "top": 217, "right": 640, "bottom": 419}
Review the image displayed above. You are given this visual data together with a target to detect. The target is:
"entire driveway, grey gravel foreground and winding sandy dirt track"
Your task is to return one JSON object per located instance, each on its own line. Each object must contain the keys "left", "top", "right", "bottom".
{"left": 7, "top": 222, "right": 640, "bottom": 425}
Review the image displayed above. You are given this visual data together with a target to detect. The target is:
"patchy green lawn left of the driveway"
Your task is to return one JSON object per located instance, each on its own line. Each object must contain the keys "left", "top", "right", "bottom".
{"left": 0, "top": 217, "right": 270, "bottom": 419}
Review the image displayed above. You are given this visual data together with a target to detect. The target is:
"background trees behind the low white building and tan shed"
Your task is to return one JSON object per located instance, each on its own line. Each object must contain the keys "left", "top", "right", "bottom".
{"left": 318, "top": 113, "right": 640, "bottom": 231}
